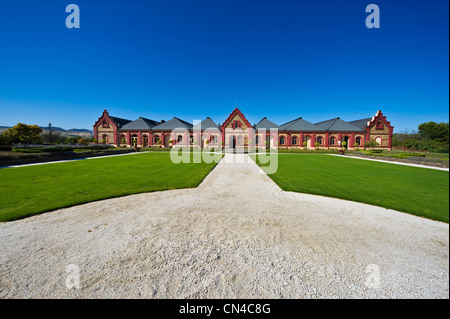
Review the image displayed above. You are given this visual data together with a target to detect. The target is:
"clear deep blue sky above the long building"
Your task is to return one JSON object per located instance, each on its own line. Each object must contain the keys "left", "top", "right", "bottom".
{"left": 0, "top": 0, "right": 449, "bottom": 131}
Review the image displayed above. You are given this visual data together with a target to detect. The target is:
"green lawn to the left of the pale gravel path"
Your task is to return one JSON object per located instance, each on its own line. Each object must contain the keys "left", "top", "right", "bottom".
{"left": 0, "top": 153, "right": 215, "bottom": 221}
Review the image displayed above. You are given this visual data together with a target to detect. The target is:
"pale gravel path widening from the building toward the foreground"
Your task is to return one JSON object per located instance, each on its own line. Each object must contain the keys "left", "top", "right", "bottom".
{"left": 0, "top": 155, "right": 449, "bottom": 298}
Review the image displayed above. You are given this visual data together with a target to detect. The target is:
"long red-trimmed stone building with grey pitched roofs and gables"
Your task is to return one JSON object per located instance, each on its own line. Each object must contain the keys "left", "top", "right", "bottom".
{"left": 94, "top": 108, "right": 394, "bottom": 150}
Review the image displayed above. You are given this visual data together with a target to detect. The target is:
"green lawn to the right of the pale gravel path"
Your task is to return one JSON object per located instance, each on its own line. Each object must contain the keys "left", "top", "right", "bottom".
{"left": 252, "top": 154, "right": 449, "bottom": 223}
